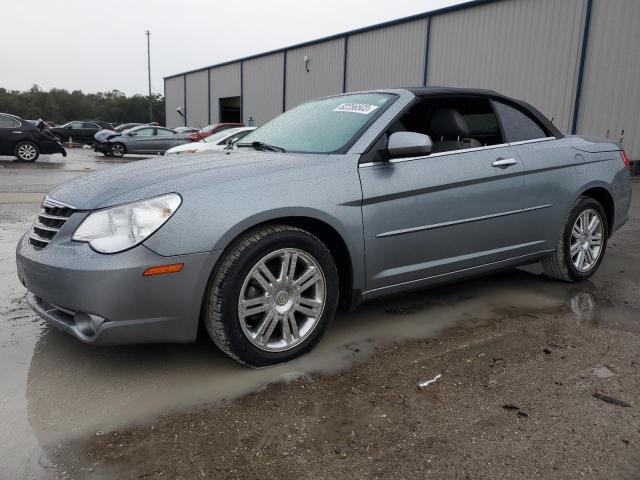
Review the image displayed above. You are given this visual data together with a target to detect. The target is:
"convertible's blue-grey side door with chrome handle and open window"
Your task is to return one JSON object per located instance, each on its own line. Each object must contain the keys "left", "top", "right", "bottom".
{"left": 359, "top": 98, "right": 530, "bottom": 293}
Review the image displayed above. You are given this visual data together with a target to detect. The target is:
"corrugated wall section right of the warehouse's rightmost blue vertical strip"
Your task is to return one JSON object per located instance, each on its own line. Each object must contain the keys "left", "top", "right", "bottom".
{"left": 578, "top": 0, "right": 640, "bottom": 160}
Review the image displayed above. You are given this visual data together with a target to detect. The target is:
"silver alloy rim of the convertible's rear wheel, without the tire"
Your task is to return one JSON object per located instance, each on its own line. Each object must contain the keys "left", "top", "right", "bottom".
{"left": 569, "top": 209, "right": 604, "bottom": 272}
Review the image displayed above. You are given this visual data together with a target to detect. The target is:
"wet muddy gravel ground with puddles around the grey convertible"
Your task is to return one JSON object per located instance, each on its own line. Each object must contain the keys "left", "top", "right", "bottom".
{"left": 0, "top": 151, "right": 640, "bottom": 479}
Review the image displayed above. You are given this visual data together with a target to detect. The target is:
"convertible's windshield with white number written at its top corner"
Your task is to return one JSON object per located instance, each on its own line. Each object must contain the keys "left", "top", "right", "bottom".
{"left": 236, "top": 93, "right": 393, "bottom": 153}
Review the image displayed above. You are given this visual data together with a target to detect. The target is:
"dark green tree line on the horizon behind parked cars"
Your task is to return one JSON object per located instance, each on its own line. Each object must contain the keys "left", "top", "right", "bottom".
{"left": 0, "top": 85, "right": 165, "bottom": 125}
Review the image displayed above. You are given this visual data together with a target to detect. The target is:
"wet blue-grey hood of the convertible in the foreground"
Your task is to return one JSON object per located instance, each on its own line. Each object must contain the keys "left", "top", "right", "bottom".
{"left": 49, "top": 150, "right": 314, "bottom": 210}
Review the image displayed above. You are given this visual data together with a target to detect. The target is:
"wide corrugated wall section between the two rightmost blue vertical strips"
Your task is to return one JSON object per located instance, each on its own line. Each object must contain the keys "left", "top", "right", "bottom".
{"left": 428, "top": 0, "right": 588, "bottom": 132}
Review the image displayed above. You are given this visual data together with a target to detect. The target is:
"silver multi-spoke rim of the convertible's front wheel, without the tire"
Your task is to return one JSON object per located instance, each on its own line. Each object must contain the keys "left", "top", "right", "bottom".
{"left": 238, "top": 248, "right": 326, "bottom": 352}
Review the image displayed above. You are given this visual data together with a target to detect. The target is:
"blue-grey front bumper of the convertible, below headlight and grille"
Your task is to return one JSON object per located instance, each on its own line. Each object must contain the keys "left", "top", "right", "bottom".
{"left": 16, "top": 232, "right": 220, "bottom": 345}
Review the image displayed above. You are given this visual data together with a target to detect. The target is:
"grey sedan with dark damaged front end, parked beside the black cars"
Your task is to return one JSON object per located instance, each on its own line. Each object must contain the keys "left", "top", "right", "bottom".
{"left": 94, "top": 125, "right": 189, "bottom": 157}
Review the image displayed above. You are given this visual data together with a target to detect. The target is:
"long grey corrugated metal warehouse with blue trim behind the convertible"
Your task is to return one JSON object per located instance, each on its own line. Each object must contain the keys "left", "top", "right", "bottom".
{"left": 164, "top": 0, "right": 640, "bottom": 160}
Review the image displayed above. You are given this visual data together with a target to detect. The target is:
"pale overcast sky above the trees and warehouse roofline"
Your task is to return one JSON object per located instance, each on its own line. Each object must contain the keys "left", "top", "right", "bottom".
{"left": 0, "top": 0, "right": 464, "bottom": 94}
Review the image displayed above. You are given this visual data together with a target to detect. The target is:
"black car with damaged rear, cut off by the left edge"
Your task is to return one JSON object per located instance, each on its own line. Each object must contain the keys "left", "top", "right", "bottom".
{"left": 0, "top": 113, "right": 67, "bottom": 162}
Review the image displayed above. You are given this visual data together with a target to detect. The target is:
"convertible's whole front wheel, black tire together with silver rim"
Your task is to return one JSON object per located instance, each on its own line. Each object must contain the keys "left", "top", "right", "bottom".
{"left": 203, "top": 225, "right": 339, "bottom": 367}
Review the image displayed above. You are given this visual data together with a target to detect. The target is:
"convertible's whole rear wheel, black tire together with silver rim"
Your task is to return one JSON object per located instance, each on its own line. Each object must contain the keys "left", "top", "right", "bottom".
{"left": 542, "top": 197, "right": 609, "bottom": 282}
